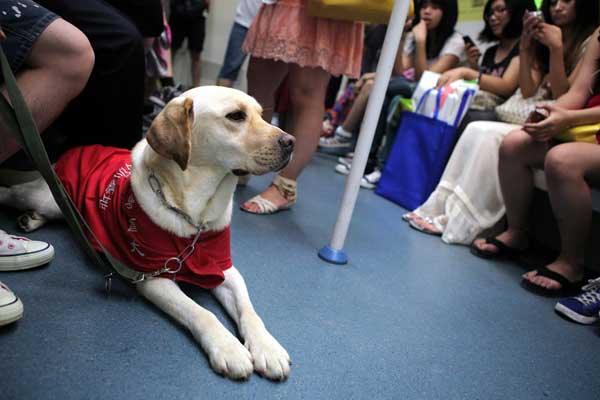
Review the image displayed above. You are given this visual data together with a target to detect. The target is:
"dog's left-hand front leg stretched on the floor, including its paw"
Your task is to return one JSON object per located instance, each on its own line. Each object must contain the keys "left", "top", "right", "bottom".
{"left": 136, "top": 278, "right": 253, "bottom": 379}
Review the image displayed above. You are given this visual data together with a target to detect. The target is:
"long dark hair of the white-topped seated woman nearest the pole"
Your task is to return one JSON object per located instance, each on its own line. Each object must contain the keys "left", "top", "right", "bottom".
{"left": 413, "top": 0, "right": 458, "bottom": 59}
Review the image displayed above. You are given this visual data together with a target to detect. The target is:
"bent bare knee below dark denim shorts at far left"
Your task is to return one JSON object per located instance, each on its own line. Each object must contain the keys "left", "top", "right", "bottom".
{"left": 3, "top": 18, "right": 94, "bottom": 132}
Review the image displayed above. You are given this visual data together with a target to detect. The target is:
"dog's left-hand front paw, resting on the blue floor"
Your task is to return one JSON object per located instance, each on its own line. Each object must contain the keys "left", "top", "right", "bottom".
{"left": 203, "top": 329, "right": 253, "bottom": 379}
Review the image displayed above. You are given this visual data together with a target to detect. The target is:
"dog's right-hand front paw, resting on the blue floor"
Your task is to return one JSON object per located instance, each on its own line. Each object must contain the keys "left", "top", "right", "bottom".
{"left": 246, "top": 328, "right": 292, "bottom": 381}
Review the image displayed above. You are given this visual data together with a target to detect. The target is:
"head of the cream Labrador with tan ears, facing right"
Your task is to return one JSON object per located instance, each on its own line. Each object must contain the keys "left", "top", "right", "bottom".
{"left": 146, "top": 86, "right": 295, "bottom": 175}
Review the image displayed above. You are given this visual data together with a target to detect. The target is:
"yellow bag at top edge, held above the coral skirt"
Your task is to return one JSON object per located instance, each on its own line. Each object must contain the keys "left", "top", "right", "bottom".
{"left": 308, "top": 0, "right": 414, "bottom": 24}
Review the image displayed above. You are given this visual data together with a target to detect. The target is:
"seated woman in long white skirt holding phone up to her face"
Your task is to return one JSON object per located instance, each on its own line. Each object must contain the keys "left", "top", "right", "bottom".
{"left": 405, "top": 0, "right": 599, "bottom": 245}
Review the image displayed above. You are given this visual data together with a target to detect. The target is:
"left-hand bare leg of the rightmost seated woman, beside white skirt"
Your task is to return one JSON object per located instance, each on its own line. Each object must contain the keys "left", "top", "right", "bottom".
{"left": 474, "top": 130, "right": 548, "bottom": 252}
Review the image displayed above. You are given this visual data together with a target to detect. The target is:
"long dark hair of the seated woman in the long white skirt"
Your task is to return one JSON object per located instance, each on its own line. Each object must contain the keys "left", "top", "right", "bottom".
{"left": 538, "top": 0, "right": 600, "bottom": 74}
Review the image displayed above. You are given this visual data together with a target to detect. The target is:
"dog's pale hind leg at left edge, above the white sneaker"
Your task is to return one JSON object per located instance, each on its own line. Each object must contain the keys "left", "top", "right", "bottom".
{"left": 0, "top": 178, "right": 62, "bottom": 232}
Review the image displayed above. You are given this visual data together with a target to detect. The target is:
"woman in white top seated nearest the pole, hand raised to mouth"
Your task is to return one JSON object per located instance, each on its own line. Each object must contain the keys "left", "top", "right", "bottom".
{"left": 328, "top": 0, "right": 464, "bottom": 189}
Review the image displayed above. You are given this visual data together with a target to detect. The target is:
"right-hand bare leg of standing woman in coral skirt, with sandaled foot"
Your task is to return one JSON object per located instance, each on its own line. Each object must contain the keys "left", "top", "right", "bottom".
{"left": 243, "top": 64, "right": 330, "bottom": 212}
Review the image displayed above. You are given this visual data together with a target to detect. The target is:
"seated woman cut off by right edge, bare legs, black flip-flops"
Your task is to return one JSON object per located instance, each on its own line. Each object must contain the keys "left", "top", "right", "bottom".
{"left": 473, "top": 25, "right": 600, "bottom": 294}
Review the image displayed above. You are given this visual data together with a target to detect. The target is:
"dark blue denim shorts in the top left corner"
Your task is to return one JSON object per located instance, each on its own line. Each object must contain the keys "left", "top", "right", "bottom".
{"left": 0, "top": 0, "right": 58, "bottom": 73}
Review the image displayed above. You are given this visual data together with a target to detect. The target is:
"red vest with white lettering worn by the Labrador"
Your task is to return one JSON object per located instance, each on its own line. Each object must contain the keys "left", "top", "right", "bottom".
{"left": 55, "top": 145, "right": 232, "bottom": 289}
